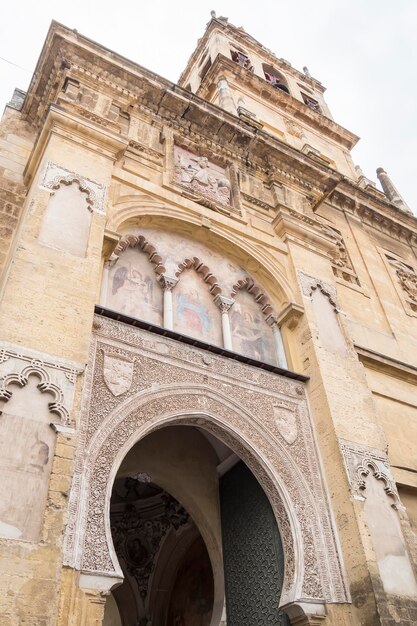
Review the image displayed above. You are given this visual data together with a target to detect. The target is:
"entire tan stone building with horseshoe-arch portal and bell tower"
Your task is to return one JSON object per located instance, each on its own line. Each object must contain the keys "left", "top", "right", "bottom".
{"left": 0, "top": 14, "right": 417, "bottom": 626}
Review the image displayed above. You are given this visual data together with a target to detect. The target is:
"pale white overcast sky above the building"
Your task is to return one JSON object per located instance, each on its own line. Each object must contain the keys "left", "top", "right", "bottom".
{"left": 0, "top": 0, "right": 417, "bottom": 213}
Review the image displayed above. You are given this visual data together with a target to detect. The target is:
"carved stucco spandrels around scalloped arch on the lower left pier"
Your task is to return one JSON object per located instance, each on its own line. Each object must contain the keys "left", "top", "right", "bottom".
{"left": 0, "top": 342, "right": 83, "bottom": 425}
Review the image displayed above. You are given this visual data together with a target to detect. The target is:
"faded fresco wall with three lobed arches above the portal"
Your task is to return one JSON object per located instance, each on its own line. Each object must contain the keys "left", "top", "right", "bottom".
{"left": 101, "top": 228, "right": 278, "bottom": 365}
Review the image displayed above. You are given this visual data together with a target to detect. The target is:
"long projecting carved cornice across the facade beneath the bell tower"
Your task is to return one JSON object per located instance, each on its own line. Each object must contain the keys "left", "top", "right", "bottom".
{"left": 19, "top": 24, "right": 340, "bottom": 192}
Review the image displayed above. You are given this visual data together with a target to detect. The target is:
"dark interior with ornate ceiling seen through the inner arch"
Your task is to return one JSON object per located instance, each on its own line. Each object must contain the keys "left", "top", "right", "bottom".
{"left": 110, "top": 475, "right": 214, "bottom": 626}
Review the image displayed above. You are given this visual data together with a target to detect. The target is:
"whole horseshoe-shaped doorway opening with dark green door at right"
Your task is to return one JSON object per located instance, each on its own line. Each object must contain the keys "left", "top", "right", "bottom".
{"left": 104, "top": 425, "right": 289, "bottom": 626}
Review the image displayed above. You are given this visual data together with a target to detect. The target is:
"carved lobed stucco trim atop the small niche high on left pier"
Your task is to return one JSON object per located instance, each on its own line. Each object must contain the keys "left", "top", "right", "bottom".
{"left": 40, "top": 161, "right": 106, "bottom": 214}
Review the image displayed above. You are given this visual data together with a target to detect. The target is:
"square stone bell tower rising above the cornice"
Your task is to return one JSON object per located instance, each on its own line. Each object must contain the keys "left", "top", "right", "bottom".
{"left": 179, "top": 11, "right": 359, "bottom": 182}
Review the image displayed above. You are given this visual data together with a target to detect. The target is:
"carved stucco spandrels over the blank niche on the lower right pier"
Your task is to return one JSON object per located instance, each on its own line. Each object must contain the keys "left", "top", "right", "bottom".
{"left": 340, "top": 439, "right": 400, "bottom": 507}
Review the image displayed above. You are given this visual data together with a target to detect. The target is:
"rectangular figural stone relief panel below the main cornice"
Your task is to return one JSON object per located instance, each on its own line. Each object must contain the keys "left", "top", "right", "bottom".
{"left": 174, "top": 146, "right": 231, "bottom": 205}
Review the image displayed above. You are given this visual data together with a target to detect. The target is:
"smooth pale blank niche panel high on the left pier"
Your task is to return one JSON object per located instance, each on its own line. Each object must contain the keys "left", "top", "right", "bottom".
{"left": 39, "top": 179, "right": 92, "bottom": 257}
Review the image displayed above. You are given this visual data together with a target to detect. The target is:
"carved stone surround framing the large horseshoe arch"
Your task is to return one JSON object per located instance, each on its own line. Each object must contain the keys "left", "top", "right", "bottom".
{"left": 64, "top": 316, "right": 348, "bottom": 604}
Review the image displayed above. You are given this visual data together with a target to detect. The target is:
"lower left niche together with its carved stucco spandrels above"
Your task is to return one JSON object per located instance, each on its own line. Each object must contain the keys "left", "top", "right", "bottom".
{"left": 0, "top": 344, "right": 79, "bottom": 541}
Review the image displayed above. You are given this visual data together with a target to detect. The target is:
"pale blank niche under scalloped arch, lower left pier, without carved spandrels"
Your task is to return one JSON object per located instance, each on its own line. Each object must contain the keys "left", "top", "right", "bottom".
{"left": 0, "top": 366, "right": 67, "bottom": 542}
